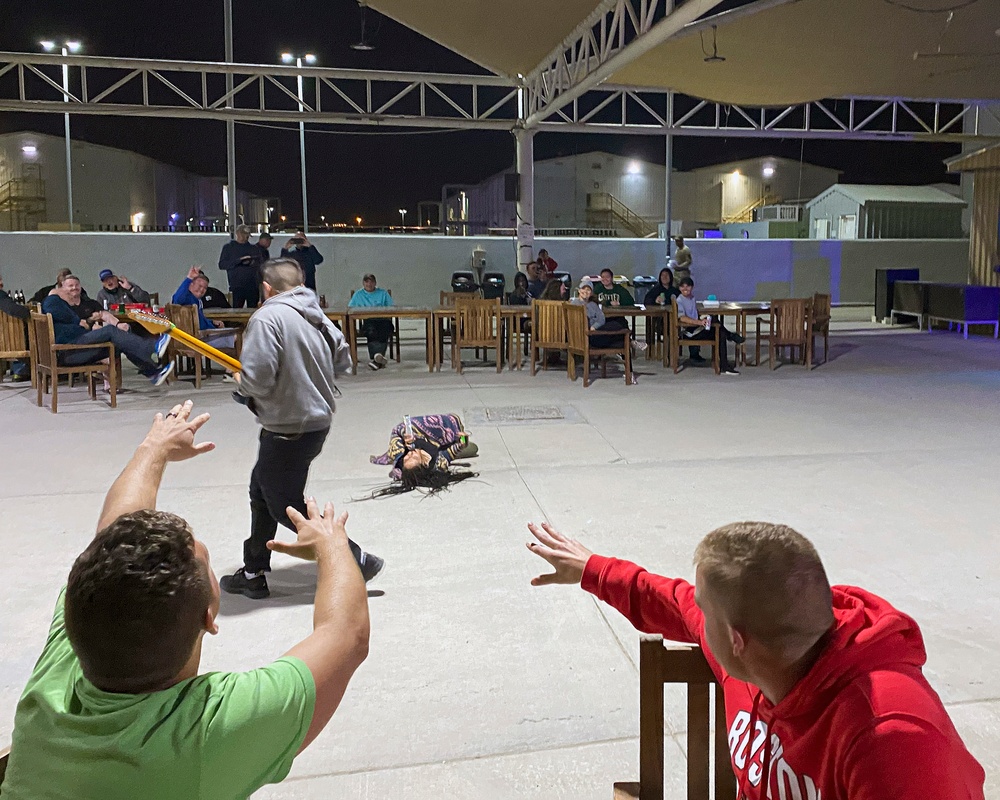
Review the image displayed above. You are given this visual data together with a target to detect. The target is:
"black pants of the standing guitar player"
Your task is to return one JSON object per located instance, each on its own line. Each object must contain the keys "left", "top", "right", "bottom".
{"left": 243, "top": 428, "right": 361, "bottom": 572}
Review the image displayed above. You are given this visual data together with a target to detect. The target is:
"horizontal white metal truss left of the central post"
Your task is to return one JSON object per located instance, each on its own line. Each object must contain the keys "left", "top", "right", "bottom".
{"left": 0, "top": 53, "right": 518, "bottom": 130}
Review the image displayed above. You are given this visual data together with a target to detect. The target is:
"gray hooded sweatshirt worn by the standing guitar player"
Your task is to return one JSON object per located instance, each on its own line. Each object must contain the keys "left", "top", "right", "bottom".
{"left": 240, "top": 286, "right": 351, "bottom": 434}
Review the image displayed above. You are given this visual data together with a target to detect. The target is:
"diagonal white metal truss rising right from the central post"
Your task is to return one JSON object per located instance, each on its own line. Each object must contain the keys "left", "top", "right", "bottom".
{"left": 525, "top": 0, "right": 722, "bottom": 128}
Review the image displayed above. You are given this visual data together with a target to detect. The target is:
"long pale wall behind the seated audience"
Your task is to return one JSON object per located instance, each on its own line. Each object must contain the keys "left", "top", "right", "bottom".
{"left": 0, "top": 232, "right": 969, "bottom": 306}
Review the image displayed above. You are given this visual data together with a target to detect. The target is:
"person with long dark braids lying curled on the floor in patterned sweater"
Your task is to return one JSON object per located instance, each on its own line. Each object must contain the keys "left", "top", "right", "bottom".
{"left": 368, "top": 414, "right": 479, "bottom": 497}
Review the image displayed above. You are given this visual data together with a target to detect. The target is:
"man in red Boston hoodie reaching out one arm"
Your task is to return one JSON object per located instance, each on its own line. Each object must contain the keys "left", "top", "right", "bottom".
{"left": 528, "top": 522, "right": 986, "bottom": 800}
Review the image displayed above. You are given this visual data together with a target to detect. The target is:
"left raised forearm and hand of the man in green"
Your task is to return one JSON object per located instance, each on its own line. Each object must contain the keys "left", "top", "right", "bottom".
{"left": 97, "top": 400, "right": 215, "bottom": 533}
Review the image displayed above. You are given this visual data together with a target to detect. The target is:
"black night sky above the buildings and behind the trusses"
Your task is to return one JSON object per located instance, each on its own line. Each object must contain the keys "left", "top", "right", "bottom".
{"left": 0, "top": 0, "right": 960, "bottom": 225}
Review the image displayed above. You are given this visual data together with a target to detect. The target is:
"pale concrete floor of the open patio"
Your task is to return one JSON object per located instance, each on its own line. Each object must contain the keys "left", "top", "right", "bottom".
{"left": 0, "top": 314, "right": 1000, "bottom": 800}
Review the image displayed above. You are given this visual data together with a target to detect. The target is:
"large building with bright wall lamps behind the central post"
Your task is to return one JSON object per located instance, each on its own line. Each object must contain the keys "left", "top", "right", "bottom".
{"left": 442, "top": 152, "right": 840, "bottom": 238}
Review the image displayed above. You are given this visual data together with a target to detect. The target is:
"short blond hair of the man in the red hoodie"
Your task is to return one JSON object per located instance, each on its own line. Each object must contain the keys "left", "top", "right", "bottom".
{"left": 694, "top": 522, "right": 833, "bottom": 654}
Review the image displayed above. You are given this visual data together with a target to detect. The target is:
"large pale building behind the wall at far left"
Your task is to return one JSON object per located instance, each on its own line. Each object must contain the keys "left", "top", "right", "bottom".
{"left": 0, "top": 131, "right": 272, "bottom": 231}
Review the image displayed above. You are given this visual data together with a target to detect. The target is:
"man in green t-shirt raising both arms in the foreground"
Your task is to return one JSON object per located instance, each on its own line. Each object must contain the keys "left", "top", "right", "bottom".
{"left": 3, "top": 401, "right": 369, "bottom": 800}
